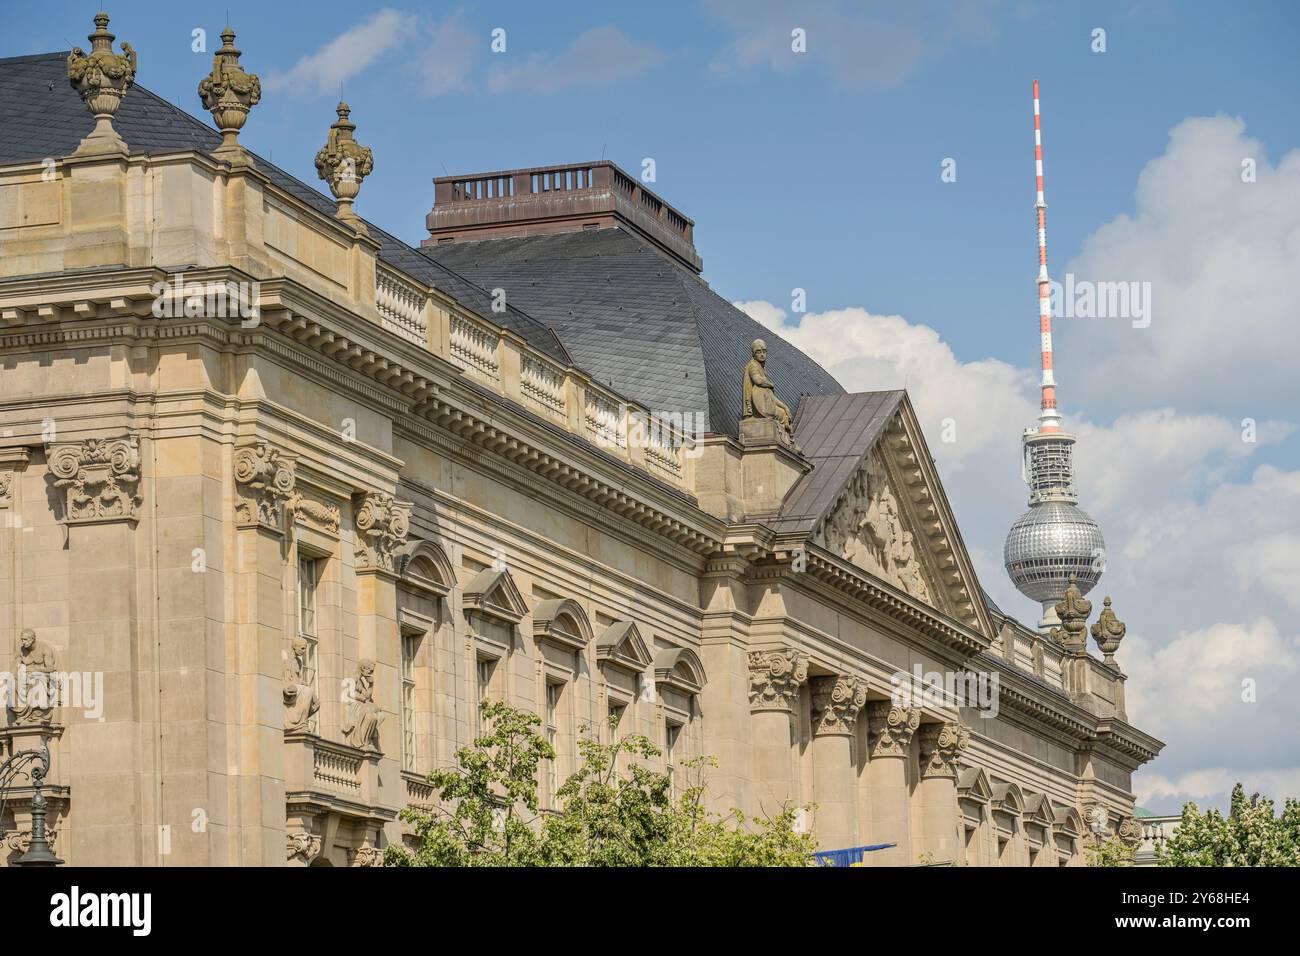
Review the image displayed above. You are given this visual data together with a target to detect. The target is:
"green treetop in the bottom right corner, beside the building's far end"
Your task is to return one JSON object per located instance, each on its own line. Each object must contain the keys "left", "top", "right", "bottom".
{"left": 1156, "top": 783, "right": 1300, "bottom": 866}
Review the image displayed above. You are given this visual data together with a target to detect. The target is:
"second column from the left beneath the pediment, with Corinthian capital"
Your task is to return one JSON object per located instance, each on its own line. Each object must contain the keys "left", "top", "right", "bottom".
{"left": 810, "top": 675, "right": 867, "bottom": 849}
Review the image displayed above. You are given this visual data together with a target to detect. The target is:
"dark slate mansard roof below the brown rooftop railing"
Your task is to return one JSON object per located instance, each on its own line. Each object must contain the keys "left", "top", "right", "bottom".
{"left": 421, "top": 229, "right": 844, "bottom": 437}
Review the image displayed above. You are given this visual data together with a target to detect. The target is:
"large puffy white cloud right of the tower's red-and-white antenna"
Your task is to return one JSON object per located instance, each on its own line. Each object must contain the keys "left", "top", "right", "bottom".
{"left": 1058, "top": 116, "right": 1300, "bottom": 420}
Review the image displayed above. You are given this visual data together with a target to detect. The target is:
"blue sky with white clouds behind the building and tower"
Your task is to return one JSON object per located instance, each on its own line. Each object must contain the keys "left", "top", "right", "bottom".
{"left": 10, "top": 0, "right": 1300, "bottom": 809}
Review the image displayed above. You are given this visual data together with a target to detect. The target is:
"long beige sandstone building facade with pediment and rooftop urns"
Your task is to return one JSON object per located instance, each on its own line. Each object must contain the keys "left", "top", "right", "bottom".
{"left": 0, "top": 17, "right": 1161, "bottom": 866}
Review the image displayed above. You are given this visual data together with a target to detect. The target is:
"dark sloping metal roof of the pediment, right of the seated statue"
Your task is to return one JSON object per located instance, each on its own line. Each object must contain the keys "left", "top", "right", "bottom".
{"left": 764, "top": 390, "right": 906, "bottom": 535}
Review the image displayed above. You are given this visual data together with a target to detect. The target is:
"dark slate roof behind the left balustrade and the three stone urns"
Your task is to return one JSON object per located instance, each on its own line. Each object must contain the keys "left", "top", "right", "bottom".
{"left": 0, "top": 52, "right": 572, "bottom": 364}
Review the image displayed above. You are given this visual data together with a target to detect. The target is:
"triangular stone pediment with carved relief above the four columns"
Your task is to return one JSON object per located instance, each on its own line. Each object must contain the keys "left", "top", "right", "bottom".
{"left": 796, "top": 395, "right": 995, "bottom": 639}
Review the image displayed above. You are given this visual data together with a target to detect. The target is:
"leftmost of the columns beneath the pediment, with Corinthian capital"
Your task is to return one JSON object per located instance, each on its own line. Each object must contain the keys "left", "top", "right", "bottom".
{"left": 749, "top": 649, "right": 809, "bottom": 814}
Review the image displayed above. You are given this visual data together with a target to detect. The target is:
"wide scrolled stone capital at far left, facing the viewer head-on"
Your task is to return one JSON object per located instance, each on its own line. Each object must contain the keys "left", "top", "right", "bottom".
{"left": 46, "top": 434, "right": 140, "bottom": 524}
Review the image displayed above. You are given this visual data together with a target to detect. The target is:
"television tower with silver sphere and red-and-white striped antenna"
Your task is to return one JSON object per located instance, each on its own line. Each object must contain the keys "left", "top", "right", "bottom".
{"left": 1002, "top": 79, "right": 1106, "bottom": 631}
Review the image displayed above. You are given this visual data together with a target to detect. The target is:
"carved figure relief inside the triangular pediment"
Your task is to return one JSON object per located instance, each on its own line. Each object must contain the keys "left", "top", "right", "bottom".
{"left": 820, "top": 455, "right": 933, "bottom": 604}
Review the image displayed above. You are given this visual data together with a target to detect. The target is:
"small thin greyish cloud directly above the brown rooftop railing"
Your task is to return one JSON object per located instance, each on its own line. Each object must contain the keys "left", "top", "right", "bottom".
{"left": 488, "top": 26, "right": 663, "bottom": 92}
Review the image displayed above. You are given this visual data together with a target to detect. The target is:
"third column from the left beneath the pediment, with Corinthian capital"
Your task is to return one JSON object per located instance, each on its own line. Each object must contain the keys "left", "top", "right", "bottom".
{"left": 866, "top": 700, "right": 920, "bottom": 866}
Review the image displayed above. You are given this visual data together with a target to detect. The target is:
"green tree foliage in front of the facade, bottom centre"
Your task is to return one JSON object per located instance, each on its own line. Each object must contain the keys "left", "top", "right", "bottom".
{"left": 385, "top": 702, "right": 815, "bottom": 866}
